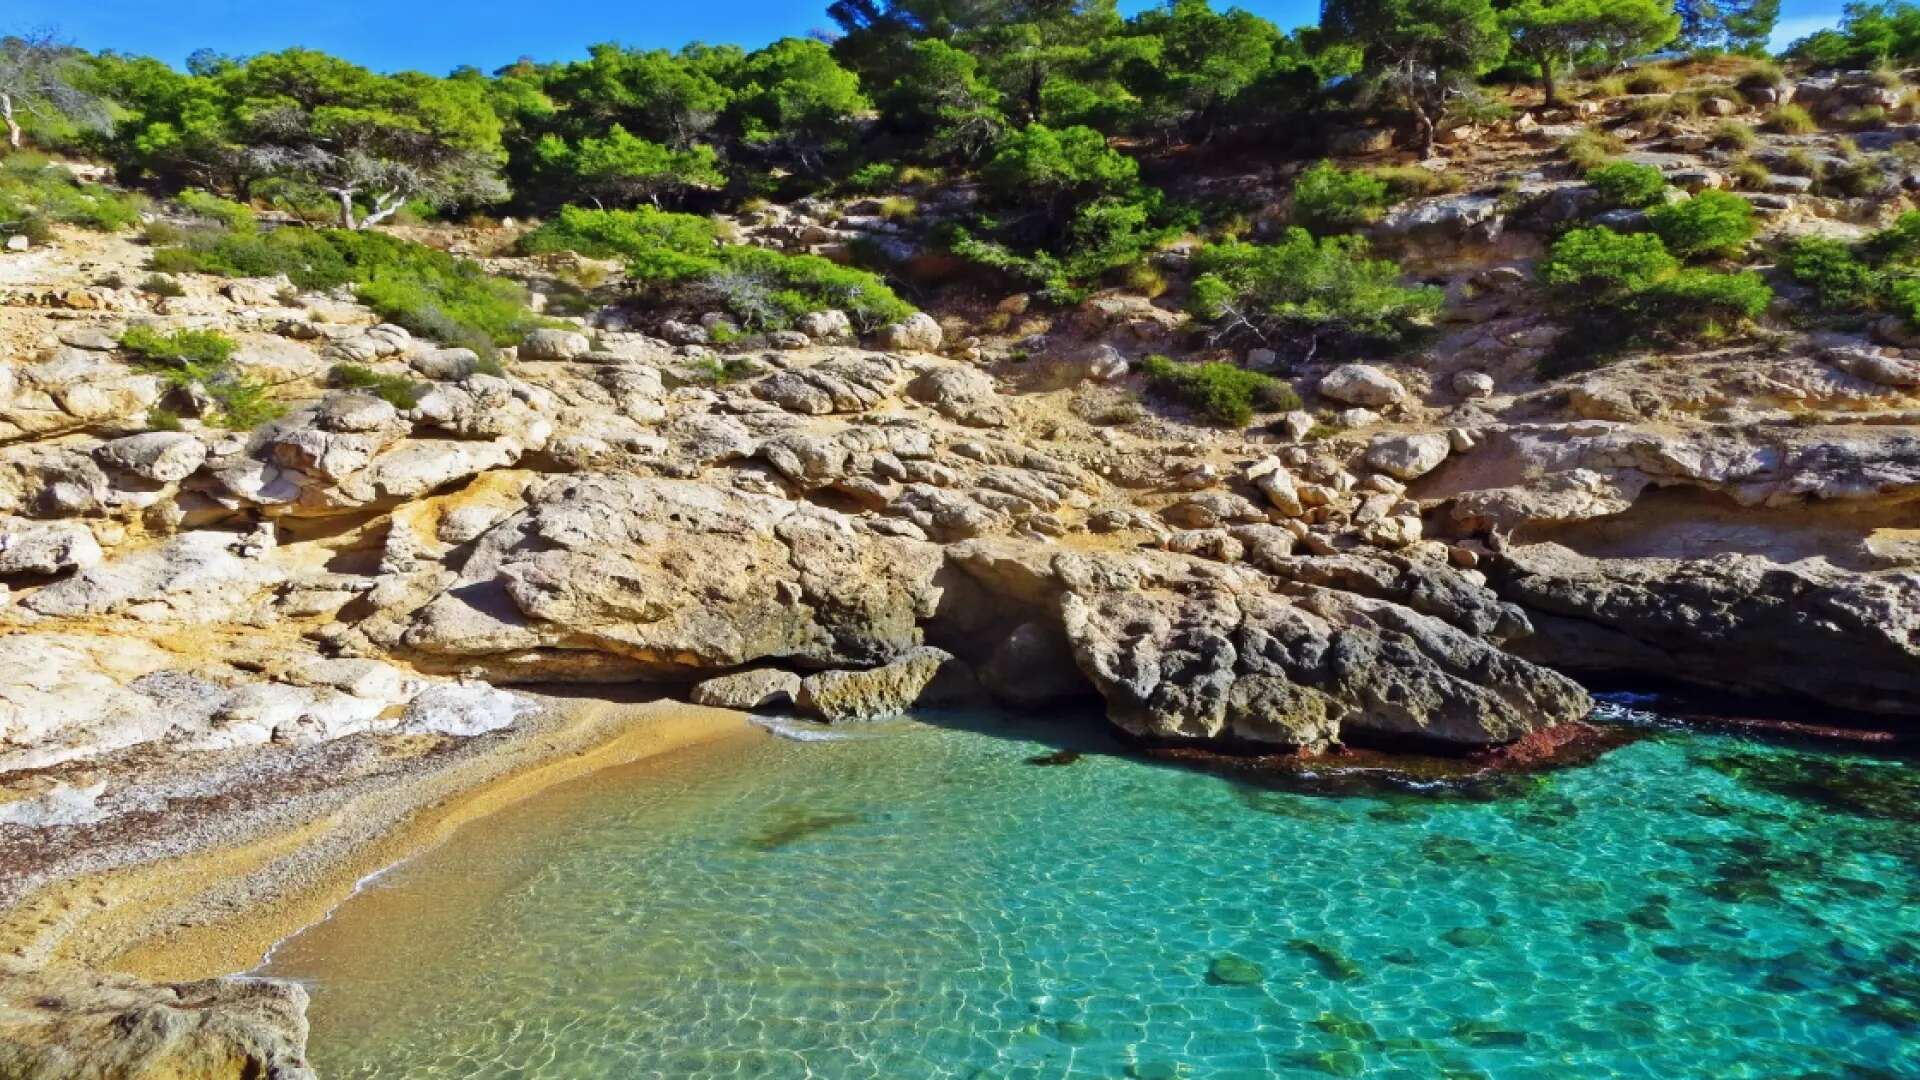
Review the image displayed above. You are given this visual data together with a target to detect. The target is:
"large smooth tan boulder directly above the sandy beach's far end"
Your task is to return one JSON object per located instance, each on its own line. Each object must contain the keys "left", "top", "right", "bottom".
{"left": 394, "top": 475, "right": 941, "bottom": 678}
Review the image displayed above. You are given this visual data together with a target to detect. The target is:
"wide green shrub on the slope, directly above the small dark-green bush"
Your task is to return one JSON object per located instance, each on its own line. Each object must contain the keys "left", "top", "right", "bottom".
{"left": 1188, "top": 229, "right": 1444, "bottom": 342}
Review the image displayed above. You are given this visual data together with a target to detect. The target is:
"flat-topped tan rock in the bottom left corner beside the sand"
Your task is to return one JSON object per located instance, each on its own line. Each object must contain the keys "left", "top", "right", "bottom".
{"left": 0, "top": 959, "right": 315, "bottom": 1080}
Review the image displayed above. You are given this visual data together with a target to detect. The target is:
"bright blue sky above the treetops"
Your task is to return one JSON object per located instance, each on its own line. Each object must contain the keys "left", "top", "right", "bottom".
{"left": 0, "top": 0, "right": 1839, "bottom": 73}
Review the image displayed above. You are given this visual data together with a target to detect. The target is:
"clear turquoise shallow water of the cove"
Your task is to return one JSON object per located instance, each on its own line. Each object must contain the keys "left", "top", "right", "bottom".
{"left": 267, "top": 707, "right": 1920, "bottom": 1080}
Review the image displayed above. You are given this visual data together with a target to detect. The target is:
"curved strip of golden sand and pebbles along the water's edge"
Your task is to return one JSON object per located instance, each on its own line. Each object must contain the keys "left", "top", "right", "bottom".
{"left": 0, "top": 694, "right": 756, "bottom": 982}
